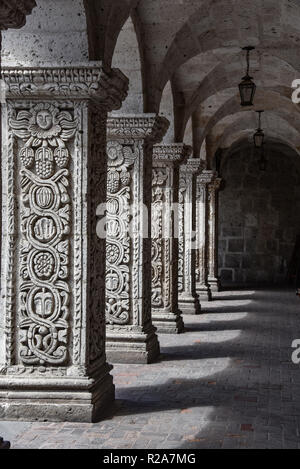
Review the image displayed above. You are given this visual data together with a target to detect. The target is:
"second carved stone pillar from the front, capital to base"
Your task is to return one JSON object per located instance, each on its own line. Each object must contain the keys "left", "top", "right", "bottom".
{"left": 106, "top": 114, "right": 168, "bottom": 363}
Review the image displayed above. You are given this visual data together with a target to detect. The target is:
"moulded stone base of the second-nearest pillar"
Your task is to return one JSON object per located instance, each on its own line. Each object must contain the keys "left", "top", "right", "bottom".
{"left": 106, "top": 325, "right": 160, "bottom": 364}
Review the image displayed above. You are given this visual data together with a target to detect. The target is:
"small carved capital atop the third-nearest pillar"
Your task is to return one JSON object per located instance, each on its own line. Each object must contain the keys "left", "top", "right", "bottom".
{"left": 153, "top": 143, "right": 191, "bottom": 166}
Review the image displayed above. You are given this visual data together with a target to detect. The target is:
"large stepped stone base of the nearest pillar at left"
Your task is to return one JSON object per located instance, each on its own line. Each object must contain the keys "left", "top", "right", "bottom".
{"left": 0, "top": 365, "right": 115, "bottom": 423}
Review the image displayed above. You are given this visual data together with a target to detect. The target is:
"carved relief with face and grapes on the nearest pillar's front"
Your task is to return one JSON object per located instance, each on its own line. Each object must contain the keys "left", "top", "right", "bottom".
{"left": 9, "top": 103, "right": 77, "bottom": 365}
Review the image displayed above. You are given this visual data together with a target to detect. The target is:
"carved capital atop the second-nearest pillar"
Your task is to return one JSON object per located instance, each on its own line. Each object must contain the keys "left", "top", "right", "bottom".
{"left": 107, "top": 114, "right": 170, "bottom": 145}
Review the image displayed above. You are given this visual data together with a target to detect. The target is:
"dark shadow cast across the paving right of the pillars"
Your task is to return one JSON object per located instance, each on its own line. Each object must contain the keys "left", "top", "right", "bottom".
{"left": 109, "top": 290, "right": 300, "bottom": 449}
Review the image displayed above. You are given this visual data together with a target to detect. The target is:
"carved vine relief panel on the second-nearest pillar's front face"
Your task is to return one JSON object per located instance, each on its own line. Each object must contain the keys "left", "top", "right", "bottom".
{"left": 106, "top": 141, "right": 134, "bottom": 325}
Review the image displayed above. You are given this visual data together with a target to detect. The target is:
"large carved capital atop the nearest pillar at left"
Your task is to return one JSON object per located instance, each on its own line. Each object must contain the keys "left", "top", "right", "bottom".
{"left": 2, "top": 62, "right": 128, "bottom": 112}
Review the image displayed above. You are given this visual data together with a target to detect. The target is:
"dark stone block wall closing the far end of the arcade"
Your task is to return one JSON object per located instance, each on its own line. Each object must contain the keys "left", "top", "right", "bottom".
{"left": 219, "top": 149, "right": 300, "bottom": 284}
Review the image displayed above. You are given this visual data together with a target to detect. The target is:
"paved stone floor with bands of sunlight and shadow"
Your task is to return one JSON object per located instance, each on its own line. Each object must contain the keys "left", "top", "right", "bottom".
{"left": 0, "top": 290, "right": 300, "bottom": 449}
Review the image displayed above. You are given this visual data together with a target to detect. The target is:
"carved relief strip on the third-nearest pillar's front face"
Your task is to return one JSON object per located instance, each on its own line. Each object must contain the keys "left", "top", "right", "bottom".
{"left": 151, "top": 168, "right": 168, "bottom": 307}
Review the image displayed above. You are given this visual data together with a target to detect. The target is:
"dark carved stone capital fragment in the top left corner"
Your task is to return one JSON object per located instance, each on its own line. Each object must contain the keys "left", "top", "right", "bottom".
{"left": 0, "top": 0, "right": 36, "bottom": 30}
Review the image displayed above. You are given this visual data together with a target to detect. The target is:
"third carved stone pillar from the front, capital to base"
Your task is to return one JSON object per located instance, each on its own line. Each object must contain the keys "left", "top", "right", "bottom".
{"left": 152, "top": 143, "right": 190, "bottom": 334}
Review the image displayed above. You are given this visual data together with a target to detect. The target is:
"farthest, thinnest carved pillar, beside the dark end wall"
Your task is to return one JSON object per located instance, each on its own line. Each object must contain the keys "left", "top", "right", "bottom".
{"left": 208, "top": 178, "right": 222, "bottom": 292}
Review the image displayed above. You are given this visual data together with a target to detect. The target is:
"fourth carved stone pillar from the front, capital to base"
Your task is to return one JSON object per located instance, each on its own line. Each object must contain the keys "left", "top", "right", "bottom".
{"left": 178, "top": 159, "right": 201, "bottom": 314}
